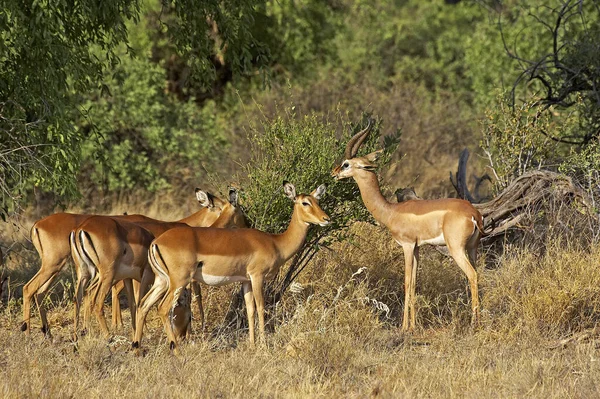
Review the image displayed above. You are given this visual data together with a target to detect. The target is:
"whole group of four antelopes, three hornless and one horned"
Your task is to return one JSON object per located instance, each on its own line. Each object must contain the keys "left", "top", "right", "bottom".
{"left": 14, "top": 122, "right": 483, "bottom": 351}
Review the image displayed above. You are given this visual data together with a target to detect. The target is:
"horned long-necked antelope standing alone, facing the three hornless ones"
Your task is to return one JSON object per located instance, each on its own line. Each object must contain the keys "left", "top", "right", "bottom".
{"left": 331, "top": 121, "right": 483, "bottom": 331}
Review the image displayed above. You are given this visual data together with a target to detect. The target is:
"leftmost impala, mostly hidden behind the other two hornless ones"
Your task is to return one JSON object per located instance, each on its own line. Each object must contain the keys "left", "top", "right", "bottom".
{"left": 21, "top": 189, "right": 232, "bottom": 336}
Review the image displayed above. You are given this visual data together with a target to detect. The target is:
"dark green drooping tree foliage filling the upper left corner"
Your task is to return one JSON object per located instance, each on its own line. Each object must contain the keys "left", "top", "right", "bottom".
{"left": 0, "top": 0, "right": 139, "bottom": 213}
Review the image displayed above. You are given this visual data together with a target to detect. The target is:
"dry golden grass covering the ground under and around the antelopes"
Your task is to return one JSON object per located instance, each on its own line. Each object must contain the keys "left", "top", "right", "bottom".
{"left": 0, "top": 214, "right": 600, "bottom": 398}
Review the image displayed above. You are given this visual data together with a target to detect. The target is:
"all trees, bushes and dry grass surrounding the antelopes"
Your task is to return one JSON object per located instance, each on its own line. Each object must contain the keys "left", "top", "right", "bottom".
{"left": 0, "top": 0, "right": 600, "bottom": 397}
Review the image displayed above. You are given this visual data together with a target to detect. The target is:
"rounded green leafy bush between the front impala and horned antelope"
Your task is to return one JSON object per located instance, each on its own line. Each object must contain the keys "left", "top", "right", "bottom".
{"left": 241, "top": 107, "right": 399, "bottom": 294}
